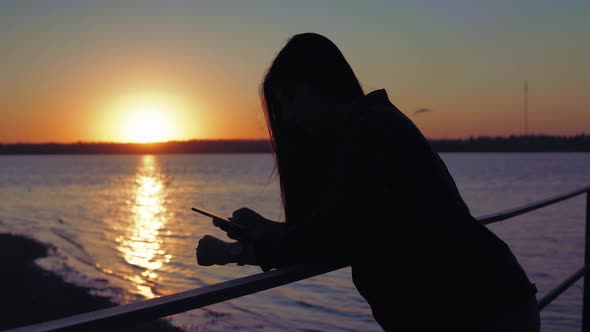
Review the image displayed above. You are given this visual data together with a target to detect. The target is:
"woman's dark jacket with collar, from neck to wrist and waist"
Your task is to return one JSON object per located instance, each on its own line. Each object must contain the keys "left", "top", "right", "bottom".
{"left": 255, "top": 90, "right": 536, "bottom": 331}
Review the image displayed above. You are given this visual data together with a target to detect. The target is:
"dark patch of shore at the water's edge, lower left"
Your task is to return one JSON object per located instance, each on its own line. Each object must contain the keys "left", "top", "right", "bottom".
{"left": 0, "top": 234, "right": 181, "bottom": 332}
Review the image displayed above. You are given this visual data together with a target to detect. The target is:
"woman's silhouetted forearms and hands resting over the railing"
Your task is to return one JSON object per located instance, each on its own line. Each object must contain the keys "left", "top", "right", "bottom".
{"left": 197, "top": 208, "right": 359, "bottom": 271}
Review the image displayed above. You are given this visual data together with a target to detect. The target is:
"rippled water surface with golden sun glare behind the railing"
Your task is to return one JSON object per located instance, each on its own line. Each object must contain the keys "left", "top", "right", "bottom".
{"left": 0, "top": 153, "right": 590, "bottom": 331}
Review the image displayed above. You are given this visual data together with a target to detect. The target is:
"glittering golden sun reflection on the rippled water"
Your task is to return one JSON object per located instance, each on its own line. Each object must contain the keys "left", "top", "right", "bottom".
{"left": 116, "top": 155, "right": 172, "bottom": 298}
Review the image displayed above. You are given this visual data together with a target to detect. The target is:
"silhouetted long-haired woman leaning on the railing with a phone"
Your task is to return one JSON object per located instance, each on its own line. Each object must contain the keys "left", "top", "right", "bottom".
{"left": 197, "top": 33, "right": 539, "bottom": 332}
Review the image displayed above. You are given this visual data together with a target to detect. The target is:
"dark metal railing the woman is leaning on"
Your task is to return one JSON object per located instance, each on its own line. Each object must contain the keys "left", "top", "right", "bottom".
{"left": 6, "top": 186, "right": 590, "bottom": 332}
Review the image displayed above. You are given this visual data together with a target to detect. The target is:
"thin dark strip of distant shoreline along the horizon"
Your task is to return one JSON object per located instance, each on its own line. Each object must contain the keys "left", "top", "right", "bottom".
{"left": 0, "top": 135, "right": 590, "bottom": 155}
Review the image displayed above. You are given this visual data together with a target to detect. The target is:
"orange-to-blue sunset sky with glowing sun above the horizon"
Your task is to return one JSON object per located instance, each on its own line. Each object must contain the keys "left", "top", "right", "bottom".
{"left": 0, "top": 0, "right": 590, "bottom": 143}
